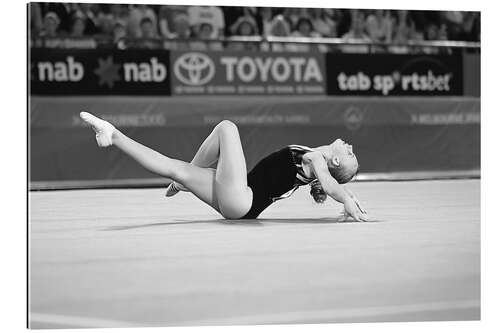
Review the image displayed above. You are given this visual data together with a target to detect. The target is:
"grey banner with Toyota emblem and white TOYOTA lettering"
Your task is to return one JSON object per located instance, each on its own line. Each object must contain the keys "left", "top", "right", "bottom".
{"left": 170, "top": 52, "right": 326, "bottom": 95}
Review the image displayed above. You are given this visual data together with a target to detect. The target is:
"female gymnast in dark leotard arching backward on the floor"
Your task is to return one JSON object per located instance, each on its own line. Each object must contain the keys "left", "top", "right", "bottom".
{"left": 80, "top": 112, "right": 368, "bottom": 221}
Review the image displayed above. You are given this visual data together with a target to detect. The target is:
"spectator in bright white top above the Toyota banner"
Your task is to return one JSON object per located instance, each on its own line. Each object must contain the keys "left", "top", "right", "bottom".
{"left": 187, "top": 6, "right": 225, "bottom": 38}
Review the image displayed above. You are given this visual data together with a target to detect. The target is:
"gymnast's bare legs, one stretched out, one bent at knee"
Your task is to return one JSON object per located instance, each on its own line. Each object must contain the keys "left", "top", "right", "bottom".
{"left": 80, "top": 112, "right": 252, "bottom": 219}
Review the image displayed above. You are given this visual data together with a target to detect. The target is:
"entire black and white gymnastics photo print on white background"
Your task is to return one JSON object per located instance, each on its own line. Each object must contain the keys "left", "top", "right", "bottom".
{"left": 26, "top": 0, "right": 482, "bottom": 329}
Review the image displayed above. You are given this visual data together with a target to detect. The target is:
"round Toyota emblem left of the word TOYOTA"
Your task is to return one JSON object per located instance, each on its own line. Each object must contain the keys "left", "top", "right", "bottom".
{"left": 174, "top": 52, "right": 215, "bottom": 86}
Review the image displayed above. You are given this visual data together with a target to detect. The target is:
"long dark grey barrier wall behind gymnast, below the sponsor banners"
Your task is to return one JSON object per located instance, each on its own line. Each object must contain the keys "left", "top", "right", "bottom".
{"left": 30, "top": 95, "right": 481, "bottom": 181}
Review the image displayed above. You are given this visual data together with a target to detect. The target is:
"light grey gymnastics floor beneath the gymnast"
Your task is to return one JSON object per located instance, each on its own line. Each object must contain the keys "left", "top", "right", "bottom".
{"left": 29, "top": 180, "right": 480, "bottom": 328}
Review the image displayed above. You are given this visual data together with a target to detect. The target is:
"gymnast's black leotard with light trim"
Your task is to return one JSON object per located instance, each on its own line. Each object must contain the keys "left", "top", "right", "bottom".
{"left": 242, "top": 145, "right": 315, "bottom": 219}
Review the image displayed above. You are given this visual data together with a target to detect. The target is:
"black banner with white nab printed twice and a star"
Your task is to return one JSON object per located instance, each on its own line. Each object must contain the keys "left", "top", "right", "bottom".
{"left": 30, "top": 48, "right": 170, "bottom": 95}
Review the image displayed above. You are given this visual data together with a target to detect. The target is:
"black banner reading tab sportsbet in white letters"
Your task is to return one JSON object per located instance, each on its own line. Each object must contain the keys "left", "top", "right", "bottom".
{"left": 326, "top": 53, "right": 463, "bottom": 96}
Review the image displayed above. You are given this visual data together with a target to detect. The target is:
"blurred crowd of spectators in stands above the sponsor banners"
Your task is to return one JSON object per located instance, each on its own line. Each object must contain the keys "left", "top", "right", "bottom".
{"left": 30, "top": 3, "right": 480, "bottom": 53}
